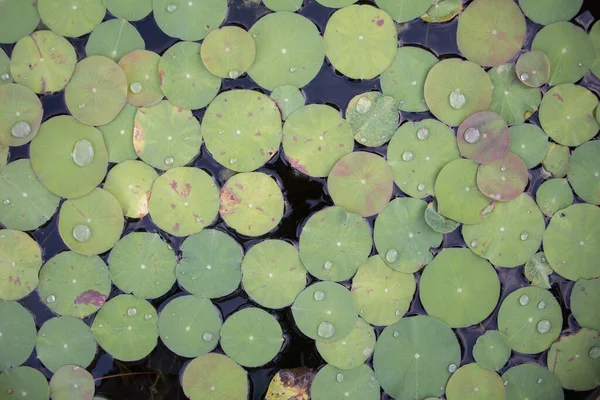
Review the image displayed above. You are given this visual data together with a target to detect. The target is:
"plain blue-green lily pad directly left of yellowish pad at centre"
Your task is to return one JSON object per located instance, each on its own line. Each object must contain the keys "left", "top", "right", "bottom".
{"left": 176, "top": 229, "right": 243, "bottom": 298}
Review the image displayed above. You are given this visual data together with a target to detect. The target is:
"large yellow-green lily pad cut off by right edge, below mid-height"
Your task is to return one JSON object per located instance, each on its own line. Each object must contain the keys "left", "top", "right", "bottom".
{"left": 544, "top": 204, "right": 600, "bottom": 280}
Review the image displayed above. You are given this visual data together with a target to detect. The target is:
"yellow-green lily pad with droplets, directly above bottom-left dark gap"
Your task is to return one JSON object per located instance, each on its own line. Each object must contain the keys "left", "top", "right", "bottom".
{"left": 91, "top": 294, "right": 158, "bottom": 361}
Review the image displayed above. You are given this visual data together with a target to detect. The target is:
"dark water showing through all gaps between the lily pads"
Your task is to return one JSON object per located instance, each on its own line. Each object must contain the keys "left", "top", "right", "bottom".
{"left": 3, "top": 0, "right": 600, "bottom": 400}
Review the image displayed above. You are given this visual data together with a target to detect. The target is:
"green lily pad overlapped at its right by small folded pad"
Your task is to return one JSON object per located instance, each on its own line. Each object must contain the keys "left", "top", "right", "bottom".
{"left": 374, "top": 197, "right": 442, "bottom": 273}
